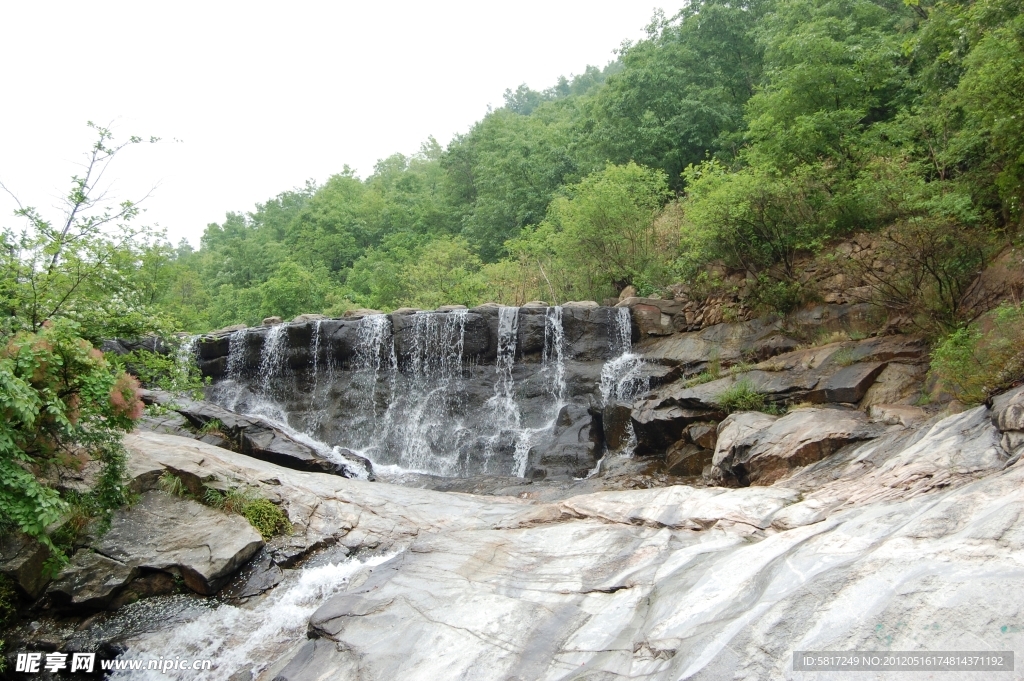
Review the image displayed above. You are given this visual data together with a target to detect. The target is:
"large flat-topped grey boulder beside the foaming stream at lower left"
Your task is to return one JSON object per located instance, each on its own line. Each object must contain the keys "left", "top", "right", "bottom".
{"left": 91, "top": 492, "right": 263, "bottom": 595}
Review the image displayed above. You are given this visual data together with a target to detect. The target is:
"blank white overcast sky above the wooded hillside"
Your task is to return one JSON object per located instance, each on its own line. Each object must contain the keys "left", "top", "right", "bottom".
{"left": 0, "top": 0, "right": 683, "bottom": 245}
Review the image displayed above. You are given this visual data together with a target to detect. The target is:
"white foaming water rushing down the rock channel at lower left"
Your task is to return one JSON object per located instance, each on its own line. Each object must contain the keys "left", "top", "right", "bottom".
{"left": 111, "top": 552, "right": 397, "bottom": 681}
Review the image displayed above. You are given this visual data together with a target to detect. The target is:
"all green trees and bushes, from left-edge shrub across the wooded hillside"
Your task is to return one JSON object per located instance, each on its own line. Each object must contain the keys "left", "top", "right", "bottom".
{"left": 0, "top": 0, "right": 1024, "bottom": 573}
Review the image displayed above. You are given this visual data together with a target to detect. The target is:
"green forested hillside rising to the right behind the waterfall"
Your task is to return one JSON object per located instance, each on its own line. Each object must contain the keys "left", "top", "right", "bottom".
{"left": 123, "top": 0, "right": 1024, "bottom": 331}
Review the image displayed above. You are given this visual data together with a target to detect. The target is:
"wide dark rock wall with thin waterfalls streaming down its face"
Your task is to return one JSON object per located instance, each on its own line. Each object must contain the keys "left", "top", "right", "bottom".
{"left": 200, "top": 306, "right": 630, "bottom": 479}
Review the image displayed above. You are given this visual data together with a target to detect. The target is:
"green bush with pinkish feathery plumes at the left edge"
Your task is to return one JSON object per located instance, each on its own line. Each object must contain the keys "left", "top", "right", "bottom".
{"left": 0, "top": 321, "right": 143, "bottom": 560}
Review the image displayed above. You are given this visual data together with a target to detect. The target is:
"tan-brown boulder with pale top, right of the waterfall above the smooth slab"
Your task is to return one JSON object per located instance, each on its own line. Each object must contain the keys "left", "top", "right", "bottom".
{"left": 712, "top": 409, "right": 884, "bottom": 486}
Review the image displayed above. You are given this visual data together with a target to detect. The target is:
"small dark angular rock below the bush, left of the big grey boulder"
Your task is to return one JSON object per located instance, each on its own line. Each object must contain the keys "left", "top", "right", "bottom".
{"left": 46, "top": 549, "right": 138, "bottom": 609}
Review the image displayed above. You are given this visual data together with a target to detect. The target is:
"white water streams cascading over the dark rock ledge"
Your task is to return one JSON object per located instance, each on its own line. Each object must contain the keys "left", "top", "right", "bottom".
{"left": 211, "top": 306, "right": 622, "bottom": 477}
